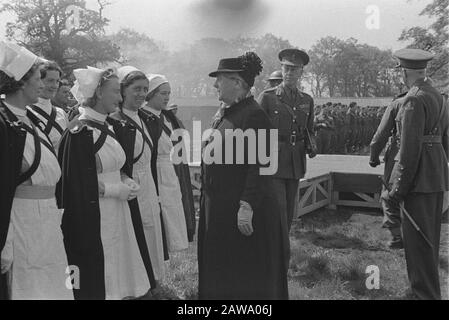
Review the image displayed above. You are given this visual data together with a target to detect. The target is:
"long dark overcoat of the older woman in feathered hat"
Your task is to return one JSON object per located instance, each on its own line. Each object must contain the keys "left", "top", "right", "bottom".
{"left": 198, "top": 97, "right": 288, "bottom": 299}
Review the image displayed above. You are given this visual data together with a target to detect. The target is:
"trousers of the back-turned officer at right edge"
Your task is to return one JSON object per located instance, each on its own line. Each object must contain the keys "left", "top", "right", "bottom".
{"left": 401, "top": 192, "right": 443, "bottom": 300}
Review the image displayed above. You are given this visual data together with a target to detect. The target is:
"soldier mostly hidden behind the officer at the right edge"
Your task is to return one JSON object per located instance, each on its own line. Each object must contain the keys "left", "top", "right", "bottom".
{"left": 369, "top": 92, "right": 407, "bottom": 249}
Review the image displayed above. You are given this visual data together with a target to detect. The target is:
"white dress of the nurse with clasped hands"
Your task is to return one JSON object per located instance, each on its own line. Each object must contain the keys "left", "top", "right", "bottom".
{"left": 79, "top": 108, "right": 150, "bottom": 300}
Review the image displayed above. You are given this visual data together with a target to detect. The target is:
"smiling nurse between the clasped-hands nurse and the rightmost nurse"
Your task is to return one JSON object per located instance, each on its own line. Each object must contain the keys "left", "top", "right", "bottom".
{"left": 109, "top": 66, "right": 164, "bottom": 280}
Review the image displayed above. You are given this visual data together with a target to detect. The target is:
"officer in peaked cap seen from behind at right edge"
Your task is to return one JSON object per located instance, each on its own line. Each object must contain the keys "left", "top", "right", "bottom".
{"left": 382, "top": 49, "right": 449, "bottom": 299}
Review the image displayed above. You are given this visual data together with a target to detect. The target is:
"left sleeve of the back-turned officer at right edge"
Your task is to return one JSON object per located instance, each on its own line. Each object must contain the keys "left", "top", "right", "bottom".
{"left": 391, "top": 98, "right": 426, "bottom": 197}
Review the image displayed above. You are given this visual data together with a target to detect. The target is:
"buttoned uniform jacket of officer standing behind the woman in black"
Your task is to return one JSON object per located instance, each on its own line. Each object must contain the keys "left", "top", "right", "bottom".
{"left": 258, "top": 84, "right": 314, "bottom": 179}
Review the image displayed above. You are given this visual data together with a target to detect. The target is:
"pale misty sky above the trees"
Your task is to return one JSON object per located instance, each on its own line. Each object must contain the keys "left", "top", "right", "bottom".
{"left": 0, "top": 0, "right": 431, "bottom": 50}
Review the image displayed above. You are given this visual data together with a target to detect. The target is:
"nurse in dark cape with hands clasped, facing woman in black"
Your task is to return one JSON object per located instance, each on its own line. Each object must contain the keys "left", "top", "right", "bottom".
{"left": 58, "top": 67, "right": 155, "bottom": 300}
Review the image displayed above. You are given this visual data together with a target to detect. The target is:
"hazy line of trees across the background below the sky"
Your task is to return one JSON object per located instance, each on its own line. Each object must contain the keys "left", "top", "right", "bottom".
{"left": 0, "top": 0, "right": 449, "bottom": 98}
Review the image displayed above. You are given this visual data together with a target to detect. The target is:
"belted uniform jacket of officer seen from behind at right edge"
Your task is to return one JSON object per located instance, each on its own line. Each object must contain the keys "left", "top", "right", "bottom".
{"left": 390, "top": 79, "right": 449, "bottom": 197}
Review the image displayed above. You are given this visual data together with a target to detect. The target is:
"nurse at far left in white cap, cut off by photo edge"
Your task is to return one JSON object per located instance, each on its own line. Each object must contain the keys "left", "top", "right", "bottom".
{"left": 0, "top": 42, "right": 73, "bottom": 300}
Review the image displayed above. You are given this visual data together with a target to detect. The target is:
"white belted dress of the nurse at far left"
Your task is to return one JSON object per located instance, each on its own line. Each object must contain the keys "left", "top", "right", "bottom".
{"left": 1, "top": 103, "right": 73, "bottom": 300}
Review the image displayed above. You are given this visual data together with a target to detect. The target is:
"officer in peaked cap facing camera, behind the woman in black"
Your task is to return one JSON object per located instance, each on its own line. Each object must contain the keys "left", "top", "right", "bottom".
{"left": 258, "top": 49, "right": 315, "bottom": 234}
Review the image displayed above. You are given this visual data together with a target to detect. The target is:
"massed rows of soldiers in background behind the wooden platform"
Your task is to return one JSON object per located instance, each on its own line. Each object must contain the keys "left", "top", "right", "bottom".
{"left": 314, "top": 102, "right": 386, "bottom": 154}
